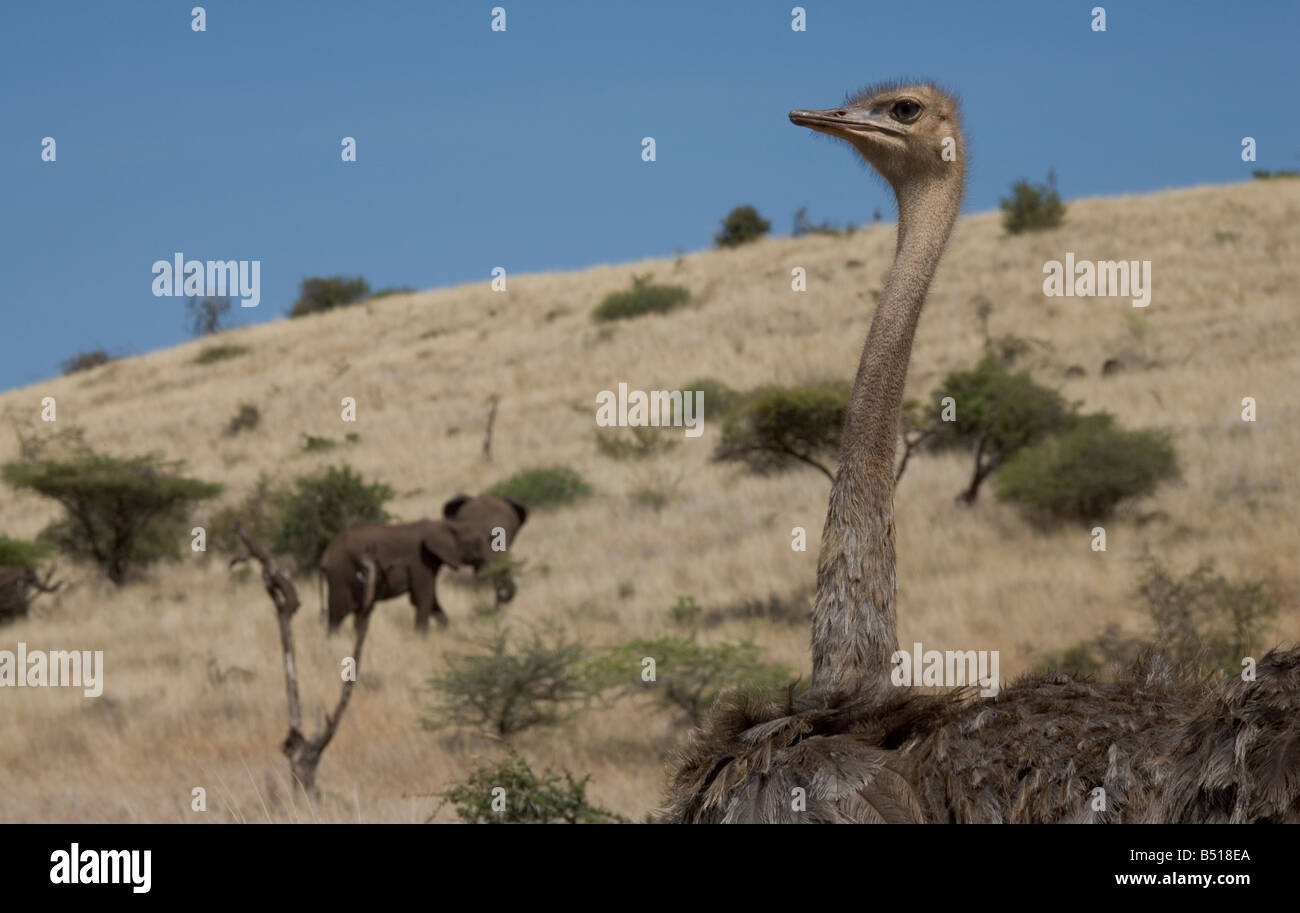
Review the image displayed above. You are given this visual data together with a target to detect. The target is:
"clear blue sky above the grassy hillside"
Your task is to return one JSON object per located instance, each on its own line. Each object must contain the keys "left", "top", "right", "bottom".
{"left": 0, "top": 0, "right": 1300, "bottom": 389}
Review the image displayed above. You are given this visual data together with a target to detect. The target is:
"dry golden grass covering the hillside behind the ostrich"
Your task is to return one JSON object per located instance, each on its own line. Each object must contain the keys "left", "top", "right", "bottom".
{"left": 0, "top": 181, "right": 1300, "bottom": 822}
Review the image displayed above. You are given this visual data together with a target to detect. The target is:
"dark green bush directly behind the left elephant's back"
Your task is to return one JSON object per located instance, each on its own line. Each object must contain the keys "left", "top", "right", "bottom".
{"left": 262, "top": 464, "right": 393, "bottom": 571}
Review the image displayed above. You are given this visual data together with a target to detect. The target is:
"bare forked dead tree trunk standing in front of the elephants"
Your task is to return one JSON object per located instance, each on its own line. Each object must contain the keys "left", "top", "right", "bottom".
{"left": 230, "top": 527, "right": 377, "bottom": 797}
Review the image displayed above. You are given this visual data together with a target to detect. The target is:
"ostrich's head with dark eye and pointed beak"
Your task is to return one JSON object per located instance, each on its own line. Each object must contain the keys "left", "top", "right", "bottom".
{"left": 790, "top": 83, "right": 965, "bottom": 195}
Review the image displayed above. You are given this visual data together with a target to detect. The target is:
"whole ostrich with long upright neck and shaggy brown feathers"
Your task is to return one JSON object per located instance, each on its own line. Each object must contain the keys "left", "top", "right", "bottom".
{"left": 663, "top": 83, "right": 1300, "bottom": 823}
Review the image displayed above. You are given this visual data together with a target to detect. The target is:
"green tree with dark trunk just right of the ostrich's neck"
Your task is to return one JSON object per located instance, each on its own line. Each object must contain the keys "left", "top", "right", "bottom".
{"left": 924, "top": 355, "right": 1073, "bottom": 503}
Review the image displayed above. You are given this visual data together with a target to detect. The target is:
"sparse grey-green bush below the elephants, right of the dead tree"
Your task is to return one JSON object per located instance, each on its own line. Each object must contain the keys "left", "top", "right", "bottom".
{"left": 421, "top": 631, "right": 594, "bottom": 737}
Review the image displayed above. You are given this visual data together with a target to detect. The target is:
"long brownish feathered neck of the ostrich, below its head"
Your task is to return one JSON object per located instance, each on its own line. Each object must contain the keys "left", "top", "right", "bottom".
{"left": 813, "top": 176, "right": 961, "bottom": 692}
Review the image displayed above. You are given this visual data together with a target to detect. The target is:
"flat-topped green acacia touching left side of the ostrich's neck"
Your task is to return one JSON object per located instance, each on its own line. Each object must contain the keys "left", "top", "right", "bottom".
{"left": 706, "top": 384, "right": 849, "bottom": 479}
